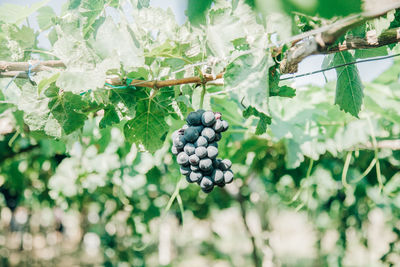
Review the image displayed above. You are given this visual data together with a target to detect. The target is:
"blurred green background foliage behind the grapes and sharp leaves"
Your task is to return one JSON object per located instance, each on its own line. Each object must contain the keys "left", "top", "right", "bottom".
{"left": 0, "top": 0, "right": 400, "bottom": 267}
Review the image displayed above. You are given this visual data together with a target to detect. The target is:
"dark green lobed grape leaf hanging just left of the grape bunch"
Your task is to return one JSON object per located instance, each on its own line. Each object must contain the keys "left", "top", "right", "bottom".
{"left": 124, "top": 91, "right": 173, "bottom": 152}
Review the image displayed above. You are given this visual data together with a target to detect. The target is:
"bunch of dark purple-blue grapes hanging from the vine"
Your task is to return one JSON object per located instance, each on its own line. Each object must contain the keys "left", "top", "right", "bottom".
{"left": 172, "top": 109, "right": 233, "bottom": 193}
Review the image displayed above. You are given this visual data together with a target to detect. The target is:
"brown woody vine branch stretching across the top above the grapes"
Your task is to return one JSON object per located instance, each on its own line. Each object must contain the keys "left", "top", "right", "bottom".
{"left": 0, "top": 2, "right": 400, "bottom": 85}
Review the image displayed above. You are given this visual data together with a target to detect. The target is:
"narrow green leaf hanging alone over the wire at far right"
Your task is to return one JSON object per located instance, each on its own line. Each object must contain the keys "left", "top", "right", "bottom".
{"left": 332, "top": 51, "right": 363, "bottom": 118}
